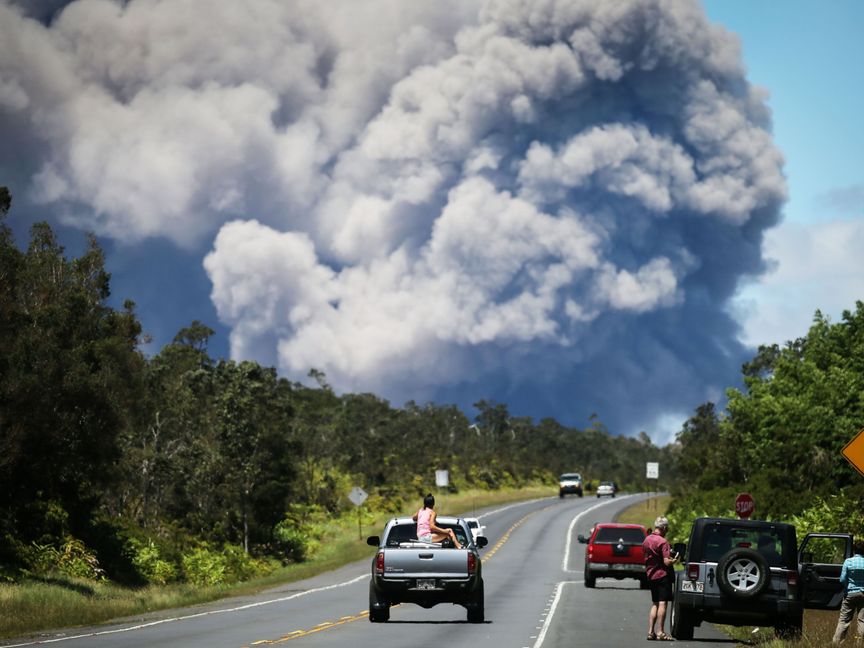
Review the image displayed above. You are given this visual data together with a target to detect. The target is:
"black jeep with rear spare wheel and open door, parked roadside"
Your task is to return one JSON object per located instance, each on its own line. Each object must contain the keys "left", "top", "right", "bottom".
{"left": 671, "top": 518, "right": 852, "bottom": 639}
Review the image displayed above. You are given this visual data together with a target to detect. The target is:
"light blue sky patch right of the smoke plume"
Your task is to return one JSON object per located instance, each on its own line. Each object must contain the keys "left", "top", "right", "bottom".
{"left": 704, "top": 0, "right": 864, "bottom": 344}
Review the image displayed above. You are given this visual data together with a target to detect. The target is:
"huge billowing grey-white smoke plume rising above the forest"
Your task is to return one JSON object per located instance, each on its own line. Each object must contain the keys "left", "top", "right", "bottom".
{"left": 0, "top": 0, "right": 785, "bottom": 436}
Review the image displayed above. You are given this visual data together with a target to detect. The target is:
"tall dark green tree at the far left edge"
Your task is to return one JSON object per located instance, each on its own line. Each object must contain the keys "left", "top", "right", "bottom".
{"left": 0, "top": 206, "right": 143, "bottom": 539}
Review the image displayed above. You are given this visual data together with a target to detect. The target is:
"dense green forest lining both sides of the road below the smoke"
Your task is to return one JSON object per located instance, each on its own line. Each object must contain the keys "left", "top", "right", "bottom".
{"left": 0, "top": 188, "right": 864, "bottom": 583}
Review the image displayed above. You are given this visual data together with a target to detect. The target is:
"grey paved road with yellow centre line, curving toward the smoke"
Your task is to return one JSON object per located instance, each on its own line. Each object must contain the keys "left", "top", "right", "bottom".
{"left": 2, "top": 495, "right": 735, "bottom": 648}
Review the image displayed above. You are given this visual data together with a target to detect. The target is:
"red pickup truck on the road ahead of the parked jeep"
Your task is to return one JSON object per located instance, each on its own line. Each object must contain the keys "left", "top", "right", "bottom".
{"left": 578, "top": 522, "right": 648, "bottom": 589}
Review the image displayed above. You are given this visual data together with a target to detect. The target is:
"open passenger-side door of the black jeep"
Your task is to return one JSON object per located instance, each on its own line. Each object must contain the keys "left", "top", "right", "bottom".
{"left": 798, "top": 533, "right": 852, "bottom": 610}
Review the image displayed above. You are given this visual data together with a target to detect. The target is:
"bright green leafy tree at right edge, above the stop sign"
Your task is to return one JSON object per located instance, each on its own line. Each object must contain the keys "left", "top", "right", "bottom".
{"left": 724, "top": 301, "right": 864, "bottom": 492}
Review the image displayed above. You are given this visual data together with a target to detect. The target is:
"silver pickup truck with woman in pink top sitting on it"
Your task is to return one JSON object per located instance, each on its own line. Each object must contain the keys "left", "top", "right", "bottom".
{"left": 366, "top": 516, "right": 488, "bottom": 623}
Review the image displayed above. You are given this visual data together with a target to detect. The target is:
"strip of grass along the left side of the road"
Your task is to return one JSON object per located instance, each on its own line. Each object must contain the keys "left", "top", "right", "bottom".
{"left": 0, "top": 485, "right": 557, "bottom": 639}
